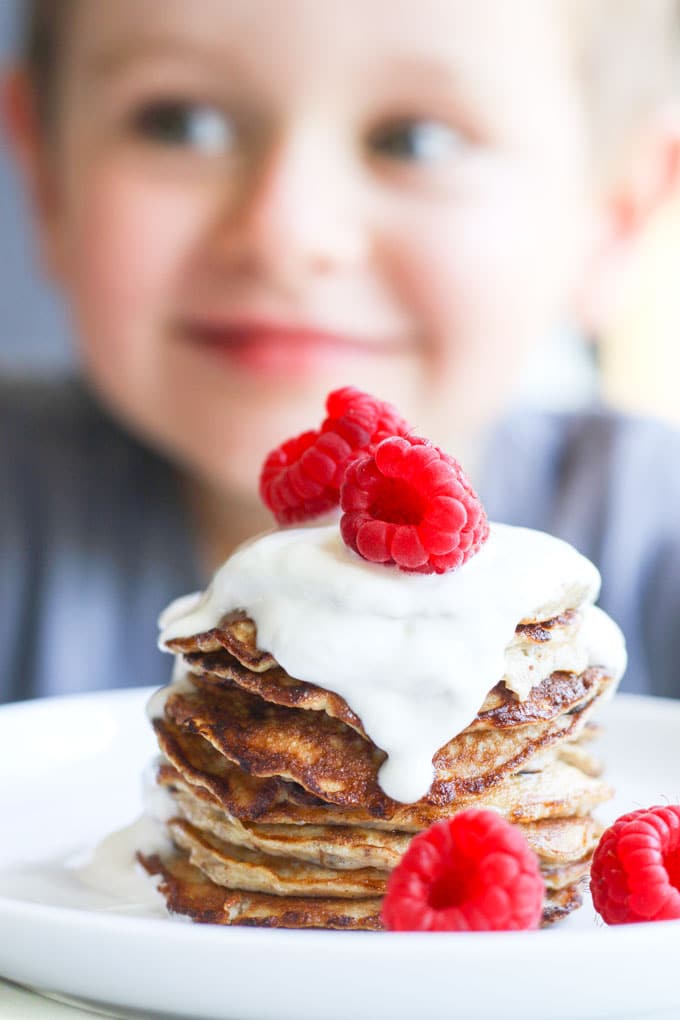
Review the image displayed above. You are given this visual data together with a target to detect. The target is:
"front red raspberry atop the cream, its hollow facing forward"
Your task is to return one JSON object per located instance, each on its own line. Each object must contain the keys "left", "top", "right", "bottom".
{"left": 341, "top": 436, "right": 488, "bottom": 573}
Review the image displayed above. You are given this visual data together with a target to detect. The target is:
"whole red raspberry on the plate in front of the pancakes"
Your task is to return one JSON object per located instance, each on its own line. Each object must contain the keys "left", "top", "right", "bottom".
{"left": 382, "top": 808, "right": 544, "bottom": 931}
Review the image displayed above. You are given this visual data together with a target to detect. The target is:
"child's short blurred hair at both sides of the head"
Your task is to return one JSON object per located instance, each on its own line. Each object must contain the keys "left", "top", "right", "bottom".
{"left": 18, "top": 0, "right": 680, "bottom": 153}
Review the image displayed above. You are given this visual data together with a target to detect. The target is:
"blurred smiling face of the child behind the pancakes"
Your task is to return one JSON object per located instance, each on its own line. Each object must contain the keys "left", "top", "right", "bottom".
{"left": 33, "top": 0, "right": 587, "bottom": 491}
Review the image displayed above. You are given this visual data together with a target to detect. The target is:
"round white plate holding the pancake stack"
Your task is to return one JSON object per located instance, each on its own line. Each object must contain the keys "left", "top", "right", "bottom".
{"left": 0, "top": 691, "right": 680, "bottom": 1020}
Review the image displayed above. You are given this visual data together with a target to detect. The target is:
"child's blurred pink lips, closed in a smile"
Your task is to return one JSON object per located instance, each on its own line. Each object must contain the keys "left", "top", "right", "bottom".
{"left": 184, "top": 322, "right": 406, "bottom": 374}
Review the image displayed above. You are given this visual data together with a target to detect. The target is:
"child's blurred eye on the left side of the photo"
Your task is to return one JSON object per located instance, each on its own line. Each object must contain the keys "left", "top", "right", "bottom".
{"left": 128, "top": 100, "right": 234, "bottom": 154}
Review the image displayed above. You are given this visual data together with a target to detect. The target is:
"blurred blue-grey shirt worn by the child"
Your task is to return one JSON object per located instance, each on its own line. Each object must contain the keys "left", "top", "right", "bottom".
{"left": 0, "top": 381, "right": 680, "bottom": 702}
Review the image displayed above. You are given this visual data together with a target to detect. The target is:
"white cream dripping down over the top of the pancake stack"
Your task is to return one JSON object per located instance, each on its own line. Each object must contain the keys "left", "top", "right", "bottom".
{"left": 160, "top": 524, "right": 625, "bottom": 803}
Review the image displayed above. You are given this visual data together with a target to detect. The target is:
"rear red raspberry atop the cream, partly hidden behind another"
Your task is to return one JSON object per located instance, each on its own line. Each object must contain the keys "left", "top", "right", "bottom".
{"left": 260, "top": 387, "right": 410, "bottom": 524}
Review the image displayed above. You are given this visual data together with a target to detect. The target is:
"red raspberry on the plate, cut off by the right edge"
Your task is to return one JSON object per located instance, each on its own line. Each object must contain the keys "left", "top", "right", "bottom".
{"left": 590, "top": 805, "right": 680, "bottom": 924}
